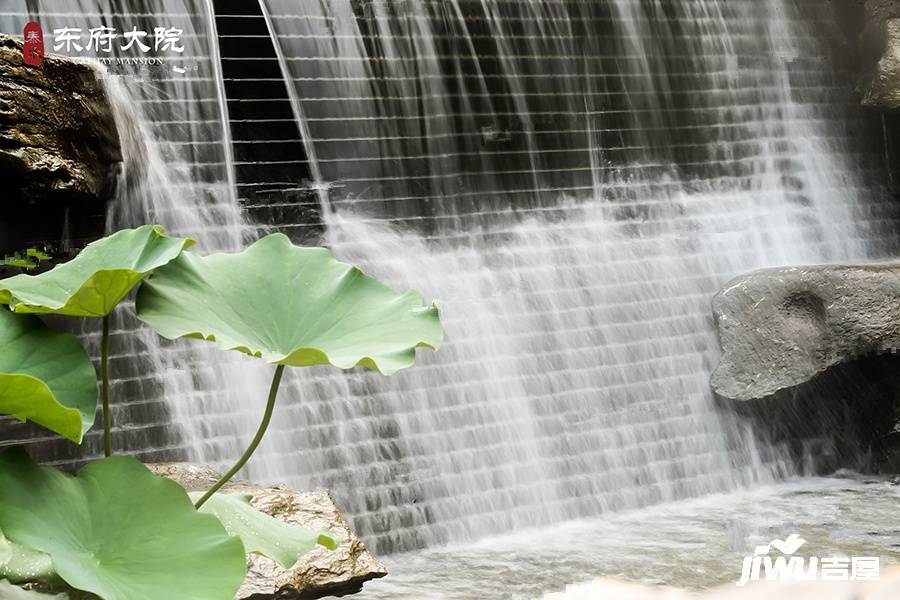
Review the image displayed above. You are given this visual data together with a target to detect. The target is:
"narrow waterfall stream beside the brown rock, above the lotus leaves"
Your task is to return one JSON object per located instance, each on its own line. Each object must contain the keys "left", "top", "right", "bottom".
{"left": 7, "top": 0, "right": 248, "bottom": 250}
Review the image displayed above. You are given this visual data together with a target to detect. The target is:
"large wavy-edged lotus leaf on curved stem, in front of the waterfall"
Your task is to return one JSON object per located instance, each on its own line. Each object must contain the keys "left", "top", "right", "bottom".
{"left": 137, "top": 233, "right": 443, "bottom": 375}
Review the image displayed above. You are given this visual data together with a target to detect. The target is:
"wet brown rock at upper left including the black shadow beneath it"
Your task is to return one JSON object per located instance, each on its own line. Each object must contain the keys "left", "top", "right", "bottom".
{"left": 0, "top": 35, "right": 122, "bottom": 257}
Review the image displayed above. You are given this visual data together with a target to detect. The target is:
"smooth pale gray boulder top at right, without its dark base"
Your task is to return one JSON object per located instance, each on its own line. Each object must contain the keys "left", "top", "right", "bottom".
{"left": 711, "top": 264, "right": 900, "bottom": 400}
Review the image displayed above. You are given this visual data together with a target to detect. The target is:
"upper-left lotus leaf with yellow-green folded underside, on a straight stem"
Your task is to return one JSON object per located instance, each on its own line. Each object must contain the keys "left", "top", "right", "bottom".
{"left": 0, "top": 225, "right": 194, "bottom": 317}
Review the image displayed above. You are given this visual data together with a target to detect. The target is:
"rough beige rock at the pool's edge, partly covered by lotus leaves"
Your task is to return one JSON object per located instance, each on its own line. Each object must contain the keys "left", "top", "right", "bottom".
{"left": 148, "top": 463, "right": 387, "bottom": 600}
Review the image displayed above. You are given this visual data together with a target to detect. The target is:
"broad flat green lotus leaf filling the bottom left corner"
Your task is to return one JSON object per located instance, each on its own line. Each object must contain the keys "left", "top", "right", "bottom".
{"left": 0, "top": 448, "right": 246, "bottom": 600}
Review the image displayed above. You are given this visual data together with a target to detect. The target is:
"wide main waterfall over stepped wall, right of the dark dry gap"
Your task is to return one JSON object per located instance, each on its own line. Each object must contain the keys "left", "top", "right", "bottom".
{"left": 172, "top": 0, "right": 894, "bottom": 551}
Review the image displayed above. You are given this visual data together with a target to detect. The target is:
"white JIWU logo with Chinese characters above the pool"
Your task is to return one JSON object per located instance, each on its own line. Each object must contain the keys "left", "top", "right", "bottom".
{"left": 736, "top": 533, "right": 881, "bottom": 587}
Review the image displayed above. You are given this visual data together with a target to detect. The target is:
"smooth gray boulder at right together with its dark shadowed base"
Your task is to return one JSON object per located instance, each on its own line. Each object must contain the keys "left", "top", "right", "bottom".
{"left": 711, "top": 264, "right": 900, "bottom": 474}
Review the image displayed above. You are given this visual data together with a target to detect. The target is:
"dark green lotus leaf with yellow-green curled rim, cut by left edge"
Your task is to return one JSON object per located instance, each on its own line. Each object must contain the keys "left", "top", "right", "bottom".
{"left": 0, "top": 309, "right": 97, "bottom": 443}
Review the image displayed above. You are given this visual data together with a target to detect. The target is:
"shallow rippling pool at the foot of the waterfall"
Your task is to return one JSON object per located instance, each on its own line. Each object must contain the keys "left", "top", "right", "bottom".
{"left": 358, "top": 473, "right": 900, "bottom": 600}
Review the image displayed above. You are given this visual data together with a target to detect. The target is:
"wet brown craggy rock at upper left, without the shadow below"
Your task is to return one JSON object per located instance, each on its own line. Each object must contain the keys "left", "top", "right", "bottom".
{"left": 0, "top": 35, "right": 122, "bottom": 203}
